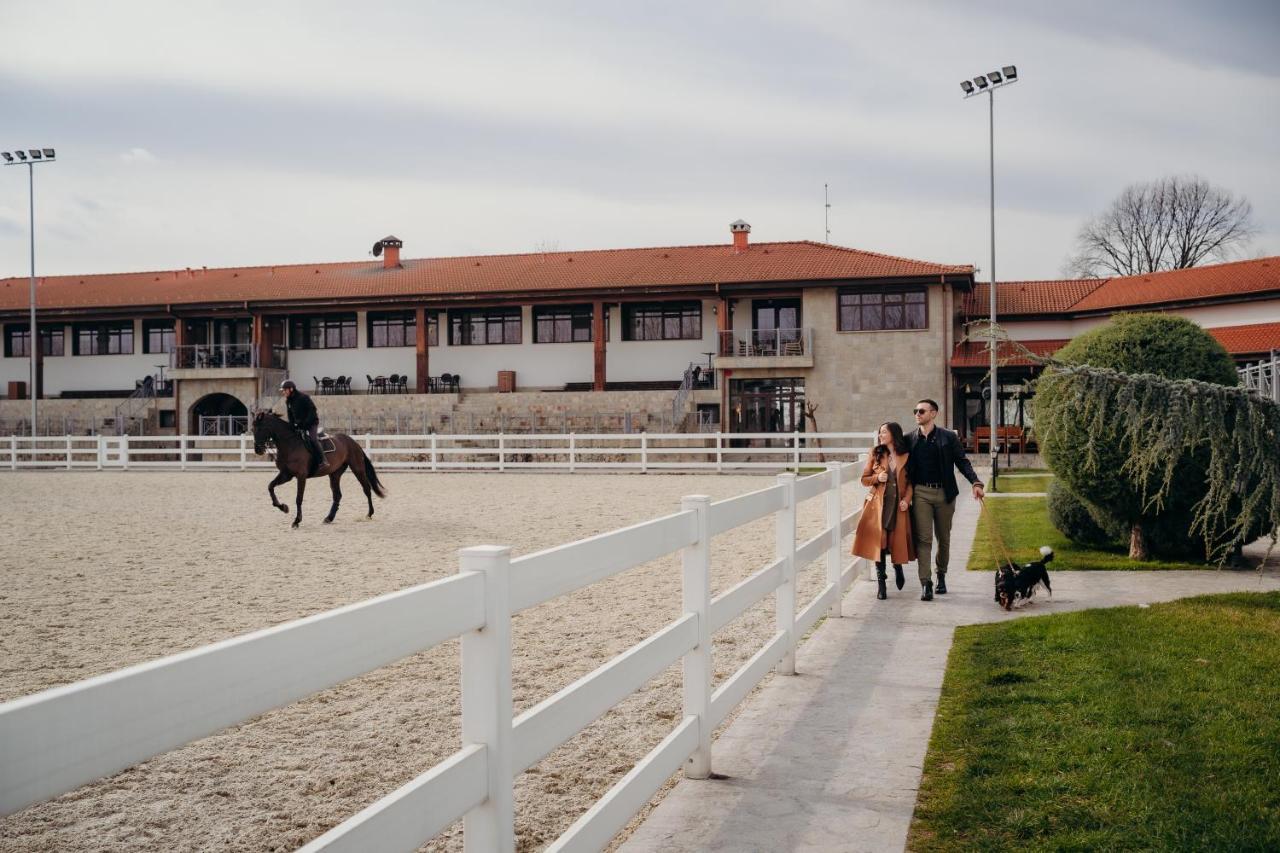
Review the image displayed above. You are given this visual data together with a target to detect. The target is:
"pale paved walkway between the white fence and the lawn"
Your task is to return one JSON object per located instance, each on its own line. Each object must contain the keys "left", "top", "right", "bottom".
{"left": 621, "top": 494, "right": 1280, "bottom": 853}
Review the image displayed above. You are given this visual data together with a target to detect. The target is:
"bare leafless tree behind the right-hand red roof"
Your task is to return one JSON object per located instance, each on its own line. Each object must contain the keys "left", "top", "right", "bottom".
{"left": 1066, "top": 175, "right": 1256, "bottom": 278}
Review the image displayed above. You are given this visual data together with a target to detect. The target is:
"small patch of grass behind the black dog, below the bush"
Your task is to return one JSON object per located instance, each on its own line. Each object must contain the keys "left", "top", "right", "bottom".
{"left": 969, "top": 494, "right": 1213, "bottom": 568}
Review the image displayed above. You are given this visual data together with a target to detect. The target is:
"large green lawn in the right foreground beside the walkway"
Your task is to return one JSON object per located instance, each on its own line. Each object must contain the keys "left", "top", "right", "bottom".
{"left": 908, "top": 593, "right": 1280, "bottom": 852}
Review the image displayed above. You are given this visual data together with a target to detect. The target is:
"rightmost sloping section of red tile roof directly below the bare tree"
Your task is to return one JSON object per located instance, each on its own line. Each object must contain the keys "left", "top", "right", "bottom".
{"left": 1071, "top": 257, "right": 1280, "bottom": 311}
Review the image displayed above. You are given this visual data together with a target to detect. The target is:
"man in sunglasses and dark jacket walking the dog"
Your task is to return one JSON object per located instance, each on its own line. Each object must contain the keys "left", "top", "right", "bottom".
{"left": 906, "top": 400, "right": 984, "bottom": 601}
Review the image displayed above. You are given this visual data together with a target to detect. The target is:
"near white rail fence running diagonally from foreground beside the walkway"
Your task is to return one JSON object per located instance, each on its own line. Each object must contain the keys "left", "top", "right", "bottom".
{"left": 0, "top": 464, "right": 861, "bottom": 852}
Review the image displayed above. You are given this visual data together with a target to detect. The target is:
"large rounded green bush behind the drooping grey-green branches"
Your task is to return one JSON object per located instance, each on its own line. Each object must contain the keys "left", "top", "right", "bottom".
{"left": 1036, "top": 314, "right": 1239, "bottom": 558}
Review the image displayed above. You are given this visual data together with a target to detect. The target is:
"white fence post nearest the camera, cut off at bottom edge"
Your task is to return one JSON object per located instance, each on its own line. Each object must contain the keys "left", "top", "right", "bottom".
{"left": 458, "top": 546, "right": 516, "bottom": 853}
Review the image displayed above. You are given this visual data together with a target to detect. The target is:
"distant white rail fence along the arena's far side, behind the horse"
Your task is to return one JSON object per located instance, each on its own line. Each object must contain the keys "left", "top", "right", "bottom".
{"left": 0, "top": 433, "right": 873, "bottom": 473}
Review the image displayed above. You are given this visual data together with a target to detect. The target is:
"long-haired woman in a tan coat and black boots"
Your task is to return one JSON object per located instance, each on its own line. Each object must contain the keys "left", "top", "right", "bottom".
{"left": 854, "top": 421, "right": 915, "bottom": 601}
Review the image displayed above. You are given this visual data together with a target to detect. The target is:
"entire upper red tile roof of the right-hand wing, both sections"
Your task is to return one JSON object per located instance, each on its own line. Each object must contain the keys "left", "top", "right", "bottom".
{"left": 964, "top": 257, "right": 1280, "bottom": 318}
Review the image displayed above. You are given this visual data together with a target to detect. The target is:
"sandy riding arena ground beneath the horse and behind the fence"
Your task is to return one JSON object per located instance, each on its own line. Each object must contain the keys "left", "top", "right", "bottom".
{"left": 0, "top": 471, "right": 861, "bottom": 850}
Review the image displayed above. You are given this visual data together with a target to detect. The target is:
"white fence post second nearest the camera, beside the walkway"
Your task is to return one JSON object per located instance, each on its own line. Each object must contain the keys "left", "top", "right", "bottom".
{"left": 680, "top": 494, "right": 714, "bottom": 779}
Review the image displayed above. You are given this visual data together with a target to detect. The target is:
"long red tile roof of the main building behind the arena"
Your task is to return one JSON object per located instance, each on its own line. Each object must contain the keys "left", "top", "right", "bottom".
{"left": 0, "top": 241, "right": 973, "bottom": 311}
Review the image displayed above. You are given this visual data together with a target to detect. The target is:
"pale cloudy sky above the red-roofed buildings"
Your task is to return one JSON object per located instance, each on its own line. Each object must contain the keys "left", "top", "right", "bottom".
{"left": 0, "top": 0, "right": 1280, "bottom": 280}
